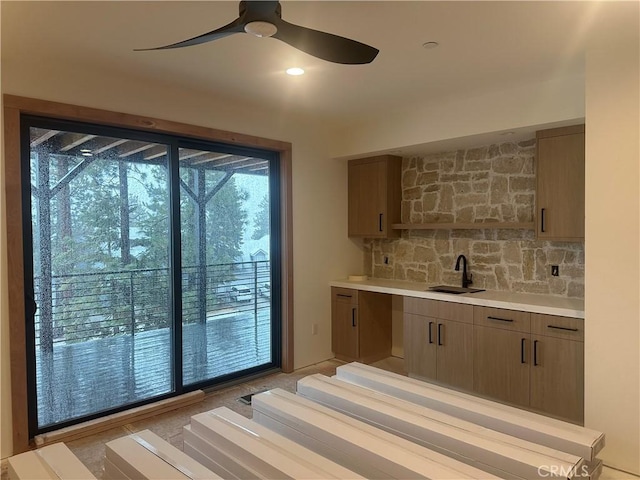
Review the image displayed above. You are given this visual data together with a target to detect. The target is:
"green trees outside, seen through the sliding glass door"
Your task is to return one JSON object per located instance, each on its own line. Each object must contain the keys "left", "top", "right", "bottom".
{"left": 32, "top": 148, "right": 250, "bottom": 342}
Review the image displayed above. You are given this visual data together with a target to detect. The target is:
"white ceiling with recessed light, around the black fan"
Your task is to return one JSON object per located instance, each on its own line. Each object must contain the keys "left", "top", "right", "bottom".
{"left": 1, "top": 0, "right": 637, "bottom": 135}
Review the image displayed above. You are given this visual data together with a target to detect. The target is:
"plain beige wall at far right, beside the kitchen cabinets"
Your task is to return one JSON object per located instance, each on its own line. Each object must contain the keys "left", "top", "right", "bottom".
{"left": 585, "top": 11, "right": 640, "bottom": 474}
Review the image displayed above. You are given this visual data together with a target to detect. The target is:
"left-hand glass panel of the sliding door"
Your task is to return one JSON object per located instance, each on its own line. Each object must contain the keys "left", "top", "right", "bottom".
{"left": 27, "top": 126, "right": 174, "bottom": 432}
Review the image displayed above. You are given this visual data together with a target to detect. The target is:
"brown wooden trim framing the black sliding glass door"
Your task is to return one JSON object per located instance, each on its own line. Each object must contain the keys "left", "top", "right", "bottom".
{"left": 3, "top": 94, "right": 293, "bottom": 454}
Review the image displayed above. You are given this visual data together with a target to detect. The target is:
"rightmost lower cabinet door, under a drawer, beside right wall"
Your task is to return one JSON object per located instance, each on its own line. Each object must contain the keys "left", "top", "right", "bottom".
{"left": 531, "top": 336, "right": 584, "bottom": 423}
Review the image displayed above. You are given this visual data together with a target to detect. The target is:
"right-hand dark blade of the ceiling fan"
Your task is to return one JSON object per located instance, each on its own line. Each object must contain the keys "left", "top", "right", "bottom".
{"left": 273, "top": 18, "right": 379, "bottom": 65}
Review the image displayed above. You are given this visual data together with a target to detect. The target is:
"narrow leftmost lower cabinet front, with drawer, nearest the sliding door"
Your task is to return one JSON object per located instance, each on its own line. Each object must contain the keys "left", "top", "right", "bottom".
{"left": 331, "top": 288, "right": 359, "bottom": 361}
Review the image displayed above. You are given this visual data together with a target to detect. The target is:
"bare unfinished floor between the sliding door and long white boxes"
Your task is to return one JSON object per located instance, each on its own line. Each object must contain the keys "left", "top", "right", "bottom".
{"left": 2, "top": 357, "right": 640, "bottom": 480}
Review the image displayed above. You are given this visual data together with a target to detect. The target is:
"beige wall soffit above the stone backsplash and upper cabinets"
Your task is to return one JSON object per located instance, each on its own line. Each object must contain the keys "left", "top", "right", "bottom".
{"left": 331, "top": 76, "right": 584, "bottom": 158}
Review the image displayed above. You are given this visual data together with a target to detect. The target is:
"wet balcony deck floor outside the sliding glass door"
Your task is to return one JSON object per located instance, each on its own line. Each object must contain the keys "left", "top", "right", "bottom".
{"left": 36, "top": 297, "right": 271, "bottom": 427}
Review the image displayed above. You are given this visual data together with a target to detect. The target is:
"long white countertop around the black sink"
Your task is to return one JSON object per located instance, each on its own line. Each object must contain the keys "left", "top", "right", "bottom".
{"left": 330, "top": 278, "right": 584, "bottom": 318}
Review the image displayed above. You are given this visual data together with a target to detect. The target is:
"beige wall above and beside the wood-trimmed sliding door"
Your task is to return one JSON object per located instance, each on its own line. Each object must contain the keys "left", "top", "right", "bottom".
{"left": 0, "top": 62, "right": 362, "bottom": 458}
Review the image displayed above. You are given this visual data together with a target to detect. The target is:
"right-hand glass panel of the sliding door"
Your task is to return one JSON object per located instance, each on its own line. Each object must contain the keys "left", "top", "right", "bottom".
{"left": 179, "top": 148, "right": 273, "bottom": 385}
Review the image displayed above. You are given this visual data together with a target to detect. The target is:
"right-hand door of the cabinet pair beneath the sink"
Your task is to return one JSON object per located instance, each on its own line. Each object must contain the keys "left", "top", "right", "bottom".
{"left": 436, "top": 319, "right": 473, "bottom": 390}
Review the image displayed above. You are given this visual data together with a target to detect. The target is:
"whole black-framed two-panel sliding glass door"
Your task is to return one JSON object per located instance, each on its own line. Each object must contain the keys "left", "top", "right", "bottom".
{"left": 21, "top": 117, "right": 280, "bottom": 435}
